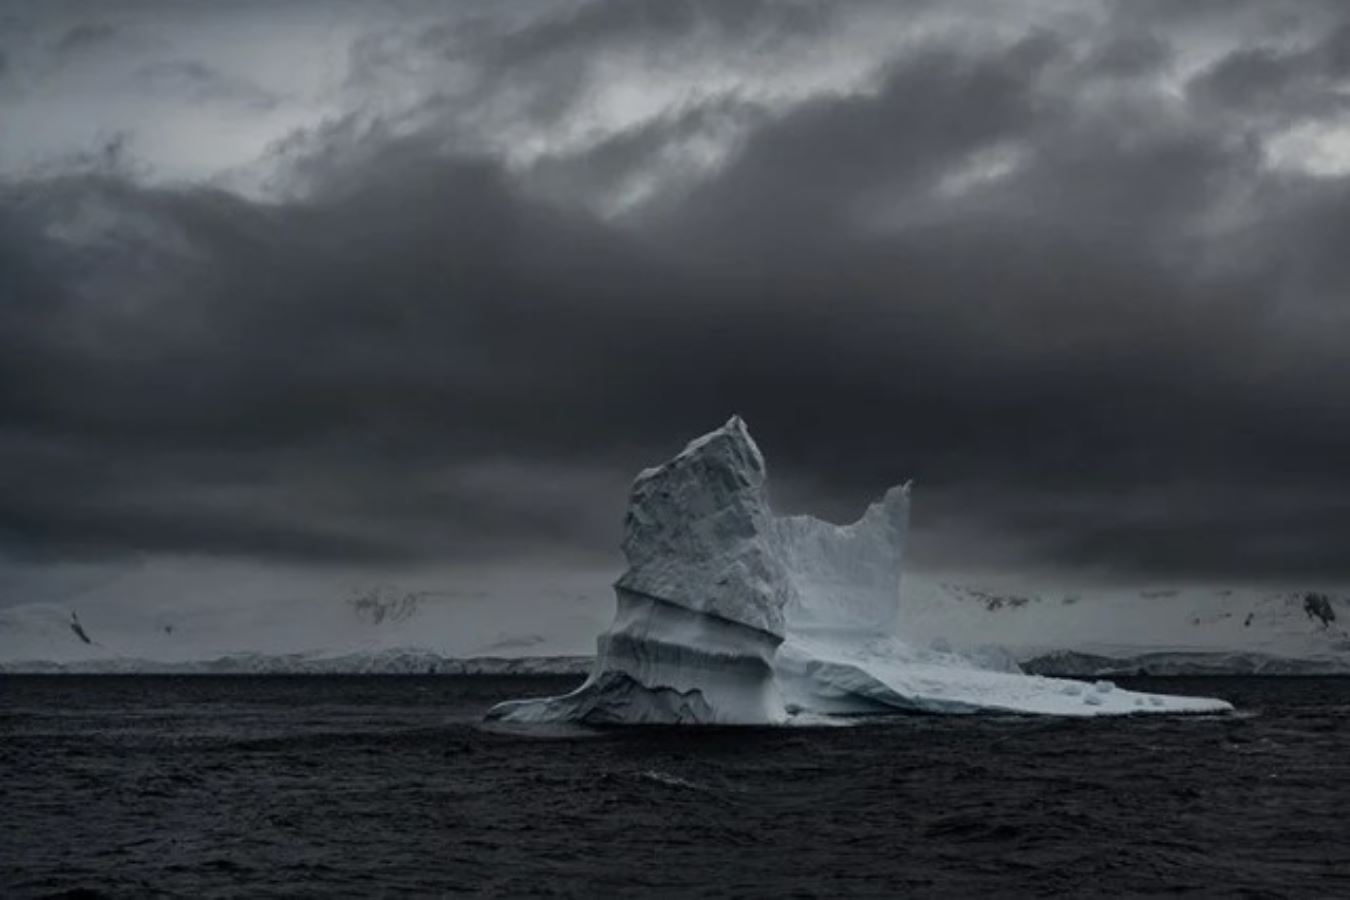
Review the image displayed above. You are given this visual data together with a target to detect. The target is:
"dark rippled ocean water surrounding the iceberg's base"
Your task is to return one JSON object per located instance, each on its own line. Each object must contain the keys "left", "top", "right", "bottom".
{"left": 0, "top": 676, "right": 1350, "bottom": 897}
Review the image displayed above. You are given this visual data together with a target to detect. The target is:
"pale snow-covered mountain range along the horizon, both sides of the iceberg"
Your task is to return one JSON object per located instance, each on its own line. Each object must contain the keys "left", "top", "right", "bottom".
{"left": 0, "top": 576, "right": 1350, "bottom": 676}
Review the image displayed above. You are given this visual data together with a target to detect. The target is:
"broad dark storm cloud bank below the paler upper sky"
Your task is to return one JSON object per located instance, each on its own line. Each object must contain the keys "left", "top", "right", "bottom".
{"left": 0, "top": 4, "right": 1350, "bottom": 578}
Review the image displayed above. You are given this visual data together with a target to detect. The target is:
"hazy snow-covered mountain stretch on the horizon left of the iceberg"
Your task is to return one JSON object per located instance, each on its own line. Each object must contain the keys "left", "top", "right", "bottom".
{"left": 0, "top": 586, "right": 605, "bottom": 673}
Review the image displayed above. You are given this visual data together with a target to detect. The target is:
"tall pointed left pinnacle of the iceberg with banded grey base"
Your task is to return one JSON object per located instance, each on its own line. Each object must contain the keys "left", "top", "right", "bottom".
{"left": 489, "top": 418, "right": 797, "bottom": 723}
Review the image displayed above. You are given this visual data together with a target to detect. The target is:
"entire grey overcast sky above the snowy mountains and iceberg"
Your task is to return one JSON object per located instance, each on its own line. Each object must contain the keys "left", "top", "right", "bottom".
{"left": 0, "top": 0, "right": 1350, "bottom": 612}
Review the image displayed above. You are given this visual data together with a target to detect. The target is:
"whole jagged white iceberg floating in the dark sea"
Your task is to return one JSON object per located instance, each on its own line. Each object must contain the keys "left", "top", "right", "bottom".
{"left": 487, "top": 417, "right": 1233, "bottom": 725}
